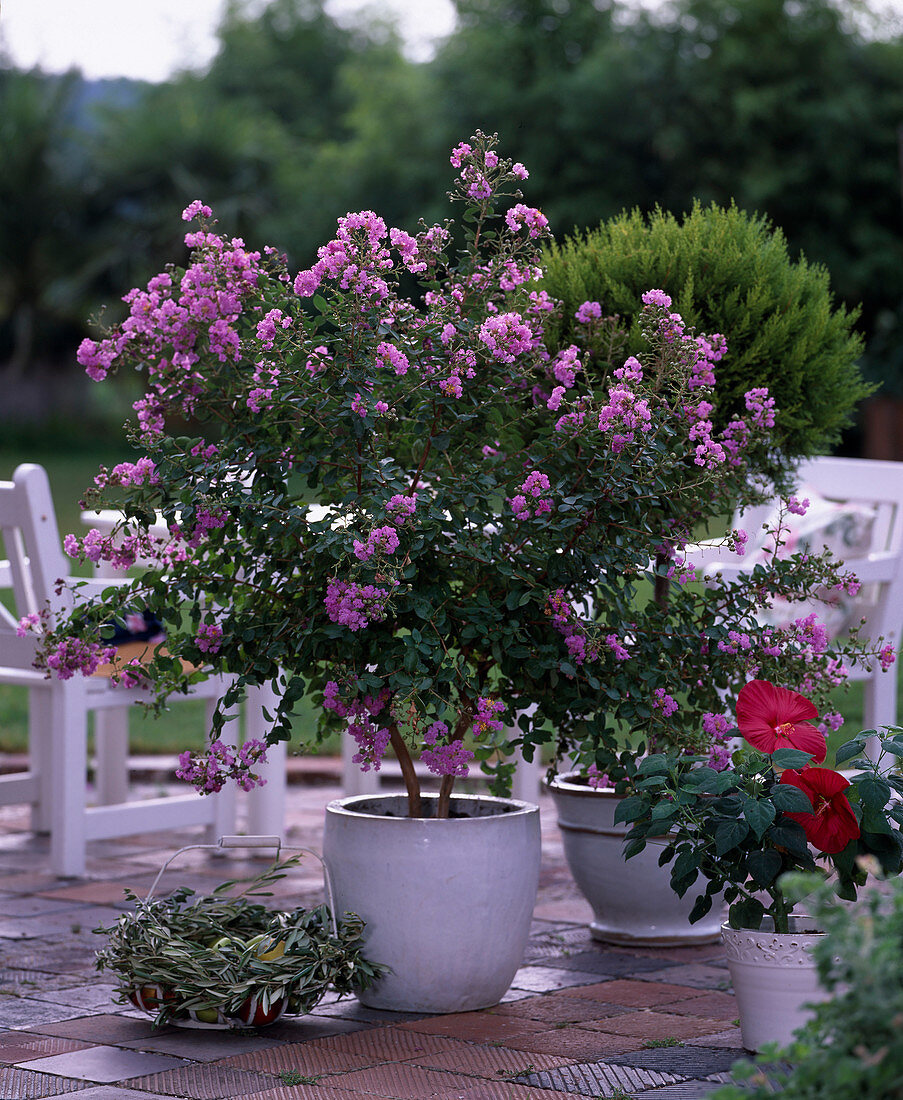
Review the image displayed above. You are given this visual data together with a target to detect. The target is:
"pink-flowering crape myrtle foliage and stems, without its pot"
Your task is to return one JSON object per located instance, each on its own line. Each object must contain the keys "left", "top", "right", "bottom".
{"left": 33, "top": 133, "right": 888, "bottom": 816}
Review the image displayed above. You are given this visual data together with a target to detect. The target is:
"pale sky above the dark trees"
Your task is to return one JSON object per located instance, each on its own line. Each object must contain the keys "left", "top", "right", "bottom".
{"left": 0, "top": 0, "right": 454, "bottom": 81}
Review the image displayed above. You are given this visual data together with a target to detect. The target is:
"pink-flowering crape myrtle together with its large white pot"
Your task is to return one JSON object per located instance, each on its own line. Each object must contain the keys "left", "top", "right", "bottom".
{"left": 30, "top": 133, "right": 893, "bottom": 1011}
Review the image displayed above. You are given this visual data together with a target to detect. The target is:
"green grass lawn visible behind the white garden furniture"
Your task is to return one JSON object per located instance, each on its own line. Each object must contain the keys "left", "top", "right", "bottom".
{"left": 0, "top": 444, "right": 903, "bottom": 762}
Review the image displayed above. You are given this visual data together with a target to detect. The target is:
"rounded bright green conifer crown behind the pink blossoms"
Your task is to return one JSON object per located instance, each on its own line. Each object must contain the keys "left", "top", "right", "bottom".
{"left": 544, "top": 202, "right": 870, "bottom": 457}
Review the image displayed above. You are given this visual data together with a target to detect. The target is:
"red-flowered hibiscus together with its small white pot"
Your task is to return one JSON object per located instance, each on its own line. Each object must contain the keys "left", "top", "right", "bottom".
{"left": 617, "top": 680, "right": 903, "bottom": 1051}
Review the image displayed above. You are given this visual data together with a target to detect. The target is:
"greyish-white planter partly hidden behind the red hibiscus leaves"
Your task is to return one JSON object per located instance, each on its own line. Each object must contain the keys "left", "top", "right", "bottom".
{"left": 550, "top": 772, "right": 723, "bottom": 947}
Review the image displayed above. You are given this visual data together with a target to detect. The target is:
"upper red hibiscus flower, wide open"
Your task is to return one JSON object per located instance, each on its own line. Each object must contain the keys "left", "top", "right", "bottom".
{"left": 737, "top": 680, "right": 827, "bottom": 763}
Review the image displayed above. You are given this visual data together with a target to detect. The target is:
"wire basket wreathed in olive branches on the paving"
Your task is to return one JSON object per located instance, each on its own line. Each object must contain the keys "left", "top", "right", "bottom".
{"left": 95, "top": 859, "right": 382, "bottom": 1029}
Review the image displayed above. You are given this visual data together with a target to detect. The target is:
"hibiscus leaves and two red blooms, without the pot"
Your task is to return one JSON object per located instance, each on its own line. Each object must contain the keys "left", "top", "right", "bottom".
{"left": 616, "top": 680, "right": 903, "bottom": 932}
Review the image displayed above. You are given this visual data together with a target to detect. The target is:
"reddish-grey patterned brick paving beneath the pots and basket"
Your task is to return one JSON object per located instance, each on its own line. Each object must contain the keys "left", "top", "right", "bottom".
{"left": 0, "top": 768, "right": 742, "bottom": 1100}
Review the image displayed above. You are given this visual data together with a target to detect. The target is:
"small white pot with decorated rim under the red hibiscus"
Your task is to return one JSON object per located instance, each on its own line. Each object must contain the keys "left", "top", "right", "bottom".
{"left": 722, "top": 917, "right": 828, "bottom": 1052}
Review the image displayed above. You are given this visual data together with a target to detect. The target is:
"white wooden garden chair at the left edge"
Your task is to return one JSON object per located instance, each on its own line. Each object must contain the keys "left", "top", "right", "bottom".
{"left": 0, "top": 464, "right": 235, "bottom": 876}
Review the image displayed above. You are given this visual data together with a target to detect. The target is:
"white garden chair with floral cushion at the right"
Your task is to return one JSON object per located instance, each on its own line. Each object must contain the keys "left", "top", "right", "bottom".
{"left": 687, "top": 457, "right": 903, "bottom": 748}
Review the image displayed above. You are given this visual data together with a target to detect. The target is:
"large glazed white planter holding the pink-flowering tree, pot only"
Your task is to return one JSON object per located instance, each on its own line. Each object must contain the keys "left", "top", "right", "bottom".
{"left": 323, "top": 794, "right": 540, "bottom": 1012}
